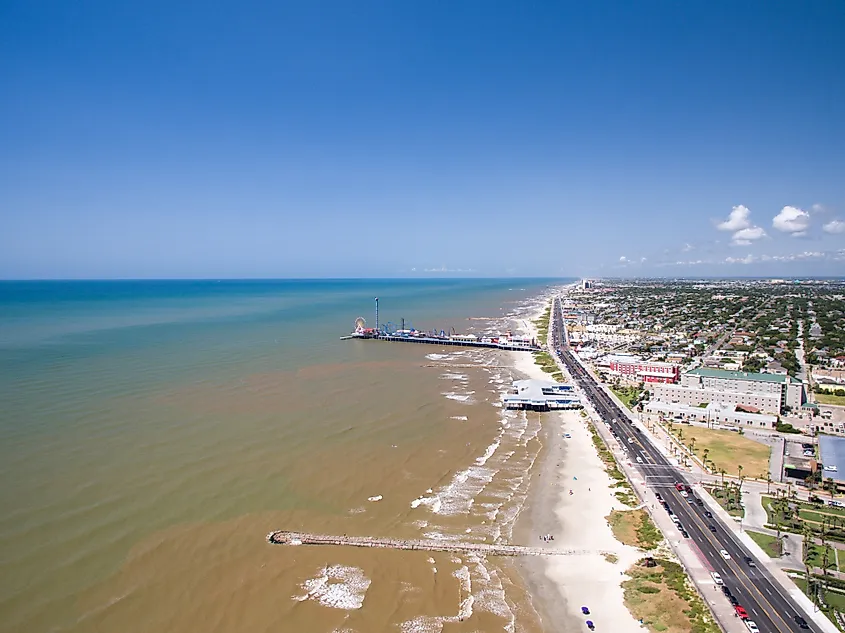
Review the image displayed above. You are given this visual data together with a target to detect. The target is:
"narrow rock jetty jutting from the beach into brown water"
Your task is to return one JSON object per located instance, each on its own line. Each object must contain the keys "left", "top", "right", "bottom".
{"left": 267, "top": 530, "right": 606, "bottom": 556}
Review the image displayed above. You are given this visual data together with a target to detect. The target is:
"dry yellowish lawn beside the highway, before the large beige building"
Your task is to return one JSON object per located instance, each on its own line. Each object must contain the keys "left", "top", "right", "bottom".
{"left": 674, "top": 424, "right": 772, "bottom": 479}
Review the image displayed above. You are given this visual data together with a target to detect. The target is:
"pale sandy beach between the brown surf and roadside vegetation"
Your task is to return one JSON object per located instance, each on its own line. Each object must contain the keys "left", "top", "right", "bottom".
{"left": 513, "top": 300, "right": 643, "bottom": 633}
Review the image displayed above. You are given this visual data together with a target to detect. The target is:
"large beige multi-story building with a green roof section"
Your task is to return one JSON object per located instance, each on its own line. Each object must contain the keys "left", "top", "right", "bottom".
{"left": 652, "top": 367, "right": 806, "bottom": 414}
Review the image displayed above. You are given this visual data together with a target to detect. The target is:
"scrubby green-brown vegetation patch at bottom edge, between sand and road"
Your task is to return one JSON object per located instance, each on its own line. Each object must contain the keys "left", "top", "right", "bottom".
{"left": 622, "top": 559, "right": 719, "bottom": 633}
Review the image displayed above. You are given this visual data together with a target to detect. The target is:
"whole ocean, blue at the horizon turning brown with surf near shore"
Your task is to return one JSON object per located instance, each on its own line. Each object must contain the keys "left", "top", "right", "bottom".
{"left": 0, "top": 279, "right": 567, "bottom": 633}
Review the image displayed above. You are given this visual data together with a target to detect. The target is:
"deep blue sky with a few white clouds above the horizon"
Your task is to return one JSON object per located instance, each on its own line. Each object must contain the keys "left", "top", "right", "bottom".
{"left": 0, "top": 0, "right": 845, "bottom": 278}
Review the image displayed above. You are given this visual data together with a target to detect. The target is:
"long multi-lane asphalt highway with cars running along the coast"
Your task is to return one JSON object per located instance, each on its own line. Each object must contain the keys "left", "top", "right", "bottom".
{"left": 552, "top": 300, "right": 818, "bottom": 633}
